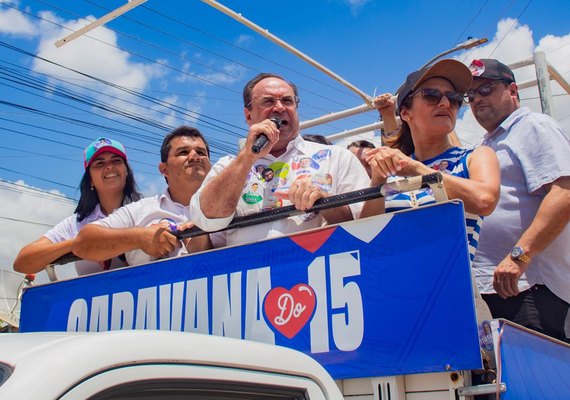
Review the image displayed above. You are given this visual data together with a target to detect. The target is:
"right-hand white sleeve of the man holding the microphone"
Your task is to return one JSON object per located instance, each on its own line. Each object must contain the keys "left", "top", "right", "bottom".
{"left": 335, "top": 147, "right": 370, "bottom": 219}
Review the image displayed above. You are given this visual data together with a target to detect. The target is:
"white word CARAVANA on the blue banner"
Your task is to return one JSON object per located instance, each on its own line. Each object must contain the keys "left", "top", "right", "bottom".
{"left": 67, "top": 267, "right": 275, "bottom": 344}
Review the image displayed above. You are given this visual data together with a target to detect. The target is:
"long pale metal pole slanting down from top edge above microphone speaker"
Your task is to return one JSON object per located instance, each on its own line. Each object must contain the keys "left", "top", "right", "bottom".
{"left": 202, "top": 0, "right": 372, "bottom": 104}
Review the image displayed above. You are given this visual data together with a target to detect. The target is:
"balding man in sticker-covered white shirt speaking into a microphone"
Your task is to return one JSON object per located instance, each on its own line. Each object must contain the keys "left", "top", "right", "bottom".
{"left": 190, "top": 73, "right": 370, "bottom": 247}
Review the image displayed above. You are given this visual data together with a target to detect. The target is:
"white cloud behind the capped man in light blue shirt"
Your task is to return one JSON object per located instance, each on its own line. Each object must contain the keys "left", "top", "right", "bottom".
{"left": 456, "top": 18, "right": 570, "bottom": 145}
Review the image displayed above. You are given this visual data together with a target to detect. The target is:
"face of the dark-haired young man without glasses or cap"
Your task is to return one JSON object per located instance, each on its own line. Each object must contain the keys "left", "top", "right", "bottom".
{"left": 159, "top": 136, "right": 211, "bottom": 186}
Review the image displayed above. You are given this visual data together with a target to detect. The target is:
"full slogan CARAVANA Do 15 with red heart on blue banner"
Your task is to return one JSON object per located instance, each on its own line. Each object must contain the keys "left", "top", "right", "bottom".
{"left": 67, "top": 251, "right": 364, "bottom": 353}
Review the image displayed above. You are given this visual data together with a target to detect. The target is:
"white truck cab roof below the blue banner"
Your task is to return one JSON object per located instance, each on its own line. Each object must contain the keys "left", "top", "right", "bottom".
{"left": 0, "top": 330, "right": 342, "bottom": 400}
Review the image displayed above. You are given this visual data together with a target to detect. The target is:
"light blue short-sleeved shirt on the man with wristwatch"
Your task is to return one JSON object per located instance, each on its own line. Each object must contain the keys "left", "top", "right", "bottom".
{"left": 473, "top": 107, "right": 570, "bottom": 302}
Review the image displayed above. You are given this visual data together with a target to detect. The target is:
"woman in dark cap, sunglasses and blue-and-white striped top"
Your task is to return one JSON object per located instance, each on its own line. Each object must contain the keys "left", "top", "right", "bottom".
{"left": 362, "top": 60, "right": 500, "bottom": 260}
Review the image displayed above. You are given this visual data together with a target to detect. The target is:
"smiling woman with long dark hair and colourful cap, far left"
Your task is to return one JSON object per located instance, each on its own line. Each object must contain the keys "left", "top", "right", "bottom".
{"left": 14, "top": 137, "right": 142, "bottom": 275}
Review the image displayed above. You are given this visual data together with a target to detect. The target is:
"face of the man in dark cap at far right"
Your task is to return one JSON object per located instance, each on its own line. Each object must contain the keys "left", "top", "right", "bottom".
{"left": 469, "top": 78, "right": 518, "bottom": 132}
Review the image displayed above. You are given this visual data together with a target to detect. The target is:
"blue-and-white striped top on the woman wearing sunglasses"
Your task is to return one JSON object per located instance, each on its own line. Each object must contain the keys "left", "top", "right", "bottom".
{"left": 386, "top": 147, "right": 483, "bottom": 261}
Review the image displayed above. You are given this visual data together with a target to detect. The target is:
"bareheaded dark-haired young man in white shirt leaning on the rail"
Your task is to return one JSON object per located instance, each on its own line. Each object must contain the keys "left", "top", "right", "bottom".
{"left": 73, "top": 126, "right": 211, "bottom": 265}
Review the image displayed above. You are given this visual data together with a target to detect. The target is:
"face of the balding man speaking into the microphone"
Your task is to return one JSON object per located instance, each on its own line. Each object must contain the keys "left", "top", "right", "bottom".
{"left": 244, "top": 77, "right": 299, "bottom": 150}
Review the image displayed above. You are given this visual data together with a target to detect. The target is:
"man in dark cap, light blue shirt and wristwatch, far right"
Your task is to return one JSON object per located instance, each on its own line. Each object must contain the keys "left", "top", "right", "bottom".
{"left": 466, "top": 59, "right": 570, "bottom": 340}
